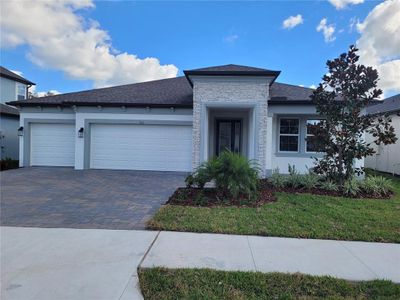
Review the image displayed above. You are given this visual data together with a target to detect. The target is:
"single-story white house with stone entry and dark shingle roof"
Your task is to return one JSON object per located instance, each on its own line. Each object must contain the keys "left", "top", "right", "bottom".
{"left": 10, "top": 65, "right": 363, "bottom": 176}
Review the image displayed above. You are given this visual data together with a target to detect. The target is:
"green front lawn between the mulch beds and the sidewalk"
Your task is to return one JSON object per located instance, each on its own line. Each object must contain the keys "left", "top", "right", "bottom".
{"left": 148, "top": 170, "right": 400, "bottom": 243}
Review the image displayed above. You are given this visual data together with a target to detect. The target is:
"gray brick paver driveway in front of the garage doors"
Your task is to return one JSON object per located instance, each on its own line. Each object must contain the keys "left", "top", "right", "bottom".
{"left": 0, "top": 168, "right": 185, "bottom": 229}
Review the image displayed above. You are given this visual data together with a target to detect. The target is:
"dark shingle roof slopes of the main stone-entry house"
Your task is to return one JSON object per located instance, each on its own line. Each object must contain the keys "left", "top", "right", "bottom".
{"left": 8, "top": 65, "right": 313, "bottom": 108}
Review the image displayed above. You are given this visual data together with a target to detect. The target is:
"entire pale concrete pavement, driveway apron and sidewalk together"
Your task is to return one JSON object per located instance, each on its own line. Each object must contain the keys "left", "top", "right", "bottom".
{"left": 0, "top": 227, "right": 400, "bottom": 300}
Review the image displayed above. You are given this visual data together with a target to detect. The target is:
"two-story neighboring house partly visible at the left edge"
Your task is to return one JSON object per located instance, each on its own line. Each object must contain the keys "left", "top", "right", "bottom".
{"left": 0, "top": 66, "right": 34, "bottom": 159}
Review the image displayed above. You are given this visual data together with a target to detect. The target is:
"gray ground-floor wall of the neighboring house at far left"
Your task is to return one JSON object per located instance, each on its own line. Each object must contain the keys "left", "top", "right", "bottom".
{"left": 0, "top": 115, "right": 19, "bottom": 159}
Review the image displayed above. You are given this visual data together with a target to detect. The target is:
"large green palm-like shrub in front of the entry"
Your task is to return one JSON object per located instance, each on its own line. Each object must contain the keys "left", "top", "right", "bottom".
{"left": 186, "top": 151, "right": 259, "bottom": 199}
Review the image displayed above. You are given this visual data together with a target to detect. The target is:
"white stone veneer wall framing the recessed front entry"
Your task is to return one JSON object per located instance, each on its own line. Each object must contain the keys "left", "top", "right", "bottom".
{"left": 191, "top": 76, "right": 270, "bottom": 175}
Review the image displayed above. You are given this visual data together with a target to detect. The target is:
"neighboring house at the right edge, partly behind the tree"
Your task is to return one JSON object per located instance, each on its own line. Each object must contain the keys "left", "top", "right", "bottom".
{"left": 365, "top": 94, "right": 400, "bottom": 175}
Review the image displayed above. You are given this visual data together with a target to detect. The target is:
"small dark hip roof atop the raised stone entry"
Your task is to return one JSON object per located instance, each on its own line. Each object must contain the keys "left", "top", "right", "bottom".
{"left": 183, "top": 64, "right": 281, "bottom": 85}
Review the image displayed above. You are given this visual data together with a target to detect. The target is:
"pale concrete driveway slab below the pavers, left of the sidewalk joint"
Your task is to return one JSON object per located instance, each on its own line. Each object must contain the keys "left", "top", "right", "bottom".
{"left": 0, "top": 227, "right": 157, "bottom": 300}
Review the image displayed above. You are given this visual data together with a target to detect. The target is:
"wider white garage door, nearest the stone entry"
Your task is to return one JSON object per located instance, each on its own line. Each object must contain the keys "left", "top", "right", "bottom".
{"left": 90, "top": 124, "right": 192, "bottom": 171}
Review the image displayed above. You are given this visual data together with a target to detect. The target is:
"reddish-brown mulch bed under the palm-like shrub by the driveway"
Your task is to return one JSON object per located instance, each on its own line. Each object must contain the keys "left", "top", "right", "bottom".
{"left": 167, "top": 188, "right": 277, "bottom": 207}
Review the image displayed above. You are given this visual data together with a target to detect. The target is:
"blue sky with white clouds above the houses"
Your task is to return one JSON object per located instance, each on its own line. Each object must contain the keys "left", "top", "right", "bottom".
{"left": 0, "top": 0, "right": 400, "bottom": 96}
